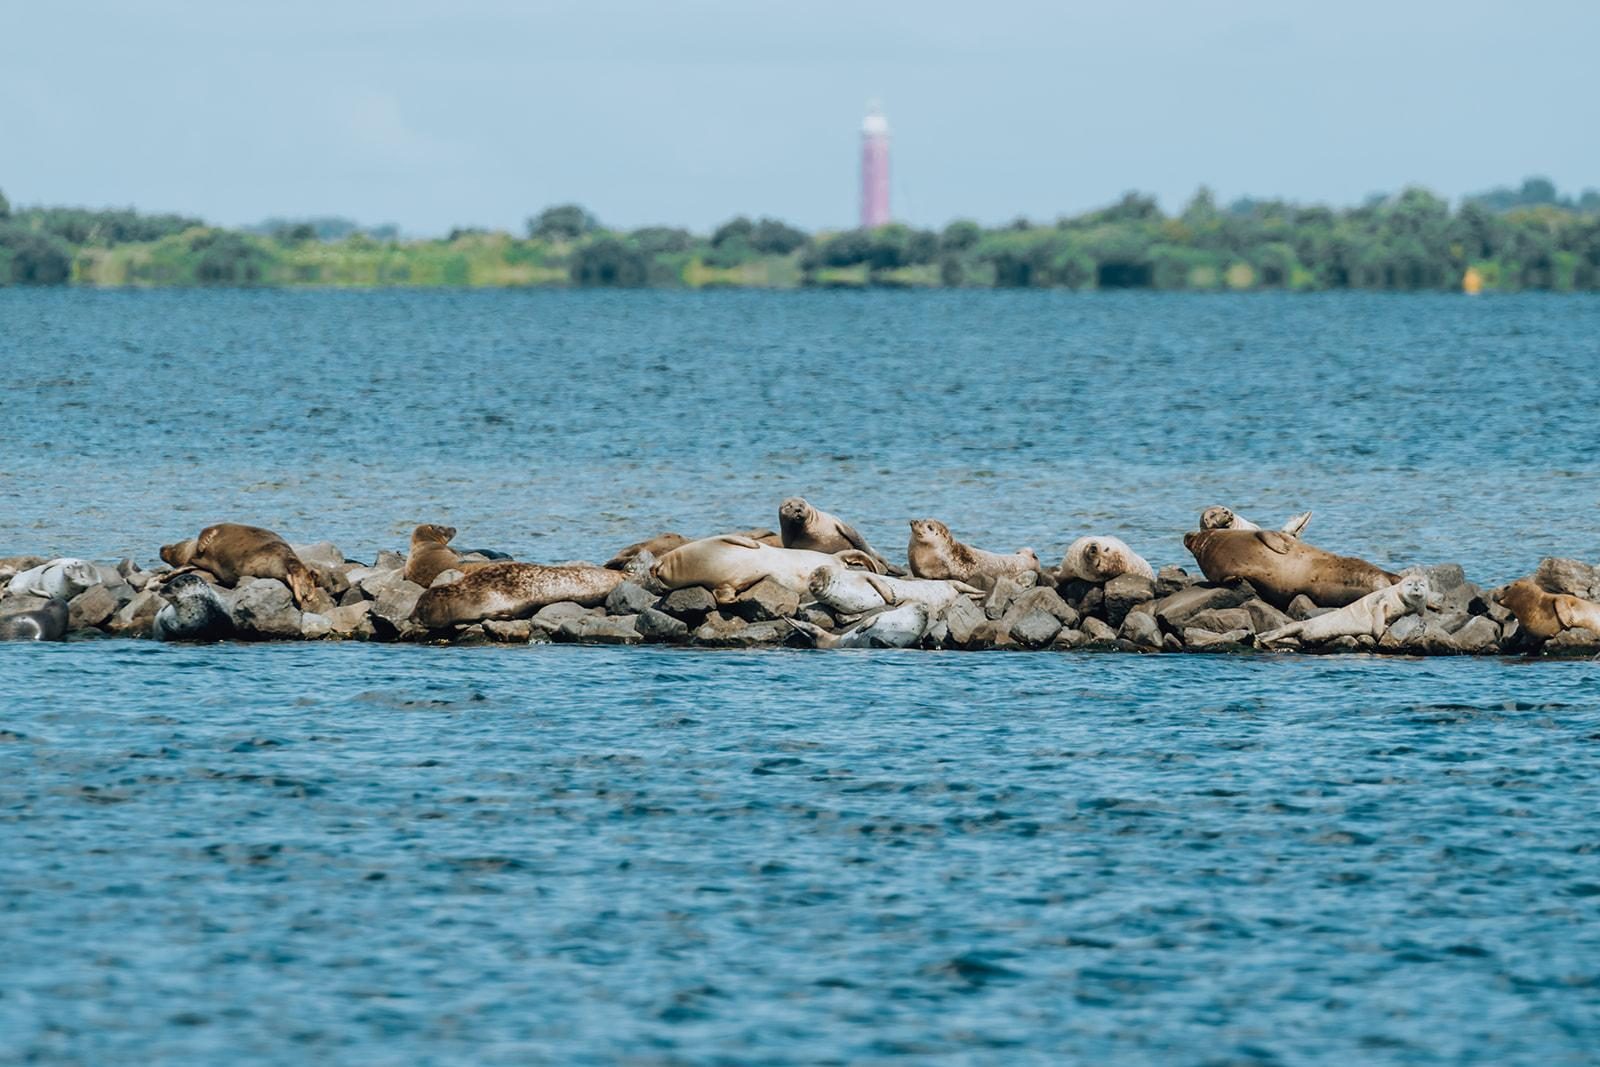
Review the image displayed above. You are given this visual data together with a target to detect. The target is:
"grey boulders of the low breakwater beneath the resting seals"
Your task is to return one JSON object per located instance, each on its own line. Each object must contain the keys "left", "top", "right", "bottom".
{"left": 0, "top": 542, "right": 1600, "bottom": 656}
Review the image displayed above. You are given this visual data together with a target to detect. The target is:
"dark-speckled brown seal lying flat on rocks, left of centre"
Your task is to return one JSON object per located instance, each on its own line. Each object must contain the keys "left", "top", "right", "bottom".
{"left": 411, "top": 563, "right": 627, "bottom": 630}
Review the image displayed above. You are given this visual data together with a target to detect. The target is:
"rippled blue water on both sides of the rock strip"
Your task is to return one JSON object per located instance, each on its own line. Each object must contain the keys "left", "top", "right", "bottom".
{"left": 0, "top": 291, "right": 1600, "bottom": 1064}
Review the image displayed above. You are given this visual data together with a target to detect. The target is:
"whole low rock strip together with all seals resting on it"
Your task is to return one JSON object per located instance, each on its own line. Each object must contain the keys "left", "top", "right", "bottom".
{"left": 0, "top": 498, "right": 1600, "bottom": 656}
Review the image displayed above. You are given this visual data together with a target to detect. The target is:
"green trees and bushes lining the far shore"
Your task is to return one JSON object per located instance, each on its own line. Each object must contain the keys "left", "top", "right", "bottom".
{"left": 0, "top": 178, "right": 1600, "bottom": 291}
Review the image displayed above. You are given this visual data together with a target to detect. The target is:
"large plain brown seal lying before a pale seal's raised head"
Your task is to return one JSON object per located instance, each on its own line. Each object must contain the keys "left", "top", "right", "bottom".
{"left": 1184, "top": 530, "right": 1400, "bottom": 611}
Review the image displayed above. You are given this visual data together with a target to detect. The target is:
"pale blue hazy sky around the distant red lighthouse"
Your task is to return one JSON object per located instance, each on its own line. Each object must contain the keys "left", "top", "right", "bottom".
{"left": 0, "top": 0, "right": 1600, "bottom": 235}
